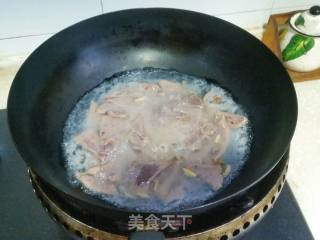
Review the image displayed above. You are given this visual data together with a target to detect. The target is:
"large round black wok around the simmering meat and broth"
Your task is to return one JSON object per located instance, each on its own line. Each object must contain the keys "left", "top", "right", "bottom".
{"left": 8, "top": 9, "right": 297, "bottom": 238}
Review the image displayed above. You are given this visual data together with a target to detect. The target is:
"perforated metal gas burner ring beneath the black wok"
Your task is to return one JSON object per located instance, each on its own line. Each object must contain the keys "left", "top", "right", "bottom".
{"left": 28, "top": 154, "right": 288, "bottom": 240}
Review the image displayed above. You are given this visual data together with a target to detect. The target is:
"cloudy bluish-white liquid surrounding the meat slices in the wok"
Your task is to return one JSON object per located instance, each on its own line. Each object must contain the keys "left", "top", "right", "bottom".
{"left": 62, "top": 68, "right": 251, "bottom": 212}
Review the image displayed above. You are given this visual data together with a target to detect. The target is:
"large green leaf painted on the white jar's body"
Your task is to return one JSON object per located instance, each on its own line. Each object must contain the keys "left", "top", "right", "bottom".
{"left": 282, "top": 34, "right": 314, "bottom": 62}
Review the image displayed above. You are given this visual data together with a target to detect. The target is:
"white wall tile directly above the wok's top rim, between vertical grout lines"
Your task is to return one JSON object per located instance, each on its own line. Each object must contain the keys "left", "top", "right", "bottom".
{"left": 102, "top": 0, "right": 273, "bottom": 15}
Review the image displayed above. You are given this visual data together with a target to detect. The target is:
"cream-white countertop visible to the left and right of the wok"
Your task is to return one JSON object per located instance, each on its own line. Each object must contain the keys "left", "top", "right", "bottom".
{"left": 0, "top": 56, "right": 320, "bottom": 239}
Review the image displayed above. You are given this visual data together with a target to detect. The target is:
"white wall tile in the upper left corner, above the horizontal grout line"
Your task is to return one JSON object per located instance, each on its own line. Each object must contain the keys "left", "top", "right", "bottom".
{"left": 0, "top": 0, "right": 102, "bottom": 39}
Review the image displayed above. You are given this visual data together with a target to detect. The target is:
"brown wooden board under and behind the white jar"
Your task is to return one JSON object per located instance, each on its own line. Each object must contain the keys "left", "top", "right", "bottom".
{"left": 262, "top": 10, "right": 320, "bottom": 82}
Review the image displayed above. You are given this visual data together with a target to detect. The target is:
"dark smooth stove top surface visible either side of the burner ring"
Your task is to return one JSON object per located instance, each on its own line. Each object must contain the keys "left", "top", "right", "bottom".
{"left": 0, "top": 110, "right": 314, "bottom": 240}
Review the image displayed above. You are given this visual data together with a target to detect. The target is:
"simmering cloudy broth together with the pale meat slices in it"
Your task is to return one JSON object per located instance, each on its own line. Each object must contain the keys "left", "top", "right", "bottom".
{"left": 62, "top": 69, "right": 250, "bottom": 211}
